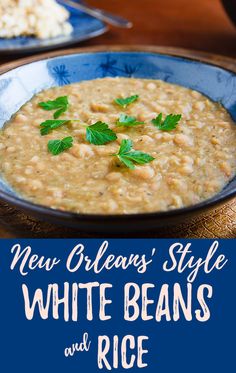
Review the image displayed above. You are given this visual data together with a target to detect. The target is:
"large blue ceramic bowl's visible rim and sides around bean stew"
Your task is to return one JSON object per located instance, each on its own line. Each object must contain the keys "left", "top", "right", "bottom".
{"left": 0, "top": 48, "right": 236, "bottom": 233}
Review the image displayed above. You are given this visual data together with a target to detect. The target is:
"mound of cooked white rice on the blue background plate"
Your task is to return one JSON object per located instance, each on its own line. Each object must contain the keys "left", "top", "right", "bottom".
{"left": 0, "top": 0, "right": 72, "bottom": 39}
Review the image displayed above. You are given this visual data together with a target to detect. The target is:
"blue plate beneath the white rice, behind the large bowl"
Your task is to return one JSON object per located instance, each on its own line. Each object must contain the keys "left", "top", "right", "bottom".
{"left": 0, "top": 1, "right": 108, "bottom": 54}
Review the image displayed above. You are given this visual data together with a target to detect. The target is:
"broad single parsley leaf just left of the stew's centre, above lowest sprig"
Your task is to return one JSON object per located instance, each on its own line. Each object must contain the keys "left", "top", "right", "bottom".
{"left": 86, "top": 122, "right": 117, "bottom": 145}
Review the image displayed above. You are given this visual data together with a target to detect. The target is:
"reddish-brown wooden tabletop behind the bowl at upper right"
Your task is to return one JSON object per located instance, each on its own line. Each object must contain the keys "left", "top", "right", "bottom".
{"left": 84, "top": 0, "right": 236, "bottom": 56}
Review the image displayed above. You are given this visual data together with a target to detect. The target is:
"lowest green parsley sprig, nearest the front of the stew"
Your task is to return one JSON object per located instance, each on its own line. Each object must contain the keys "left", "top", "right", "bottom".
{"left": 113, "top": 140, "right": 155, "bottom": 170}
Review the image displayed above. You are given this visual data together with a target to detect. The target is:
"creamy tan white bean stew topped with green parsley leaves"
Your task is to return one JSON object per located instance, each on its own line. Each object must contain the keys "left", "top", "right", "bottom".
{"left": 0, "top": 78, "right": 236, "bottom": 214}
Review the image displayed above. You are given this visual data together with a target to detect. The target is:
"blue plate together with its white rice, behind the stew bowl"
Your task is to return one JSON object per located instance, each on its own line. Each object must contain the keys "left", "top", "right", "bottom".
{"left": 0, "top": 0, "right": 107, "bottom": 54}
